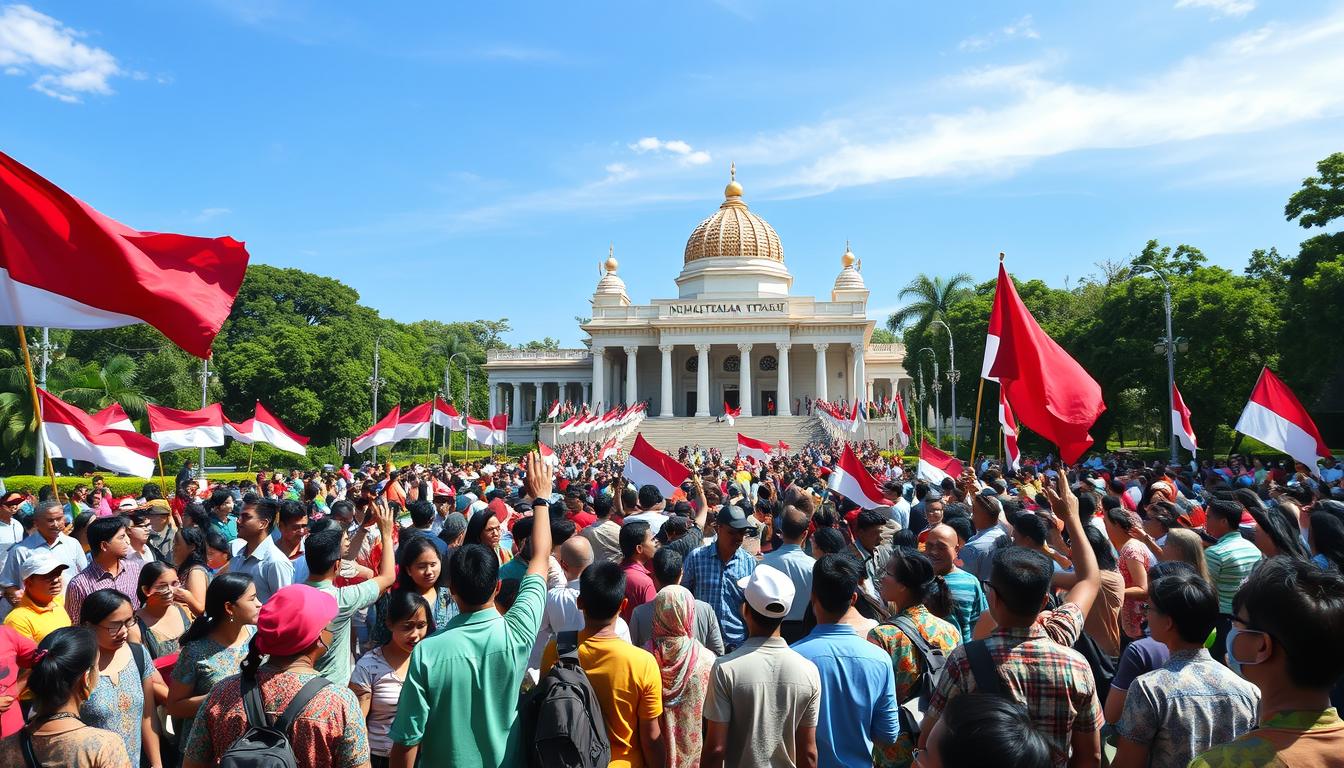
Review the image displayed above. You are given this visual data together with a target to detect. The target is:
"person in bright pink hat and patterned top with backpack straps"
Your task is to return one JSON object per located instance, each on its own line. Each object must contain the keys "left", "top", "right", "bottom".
{"left": 183, "top": 584, "right": 368, "bottom": 768}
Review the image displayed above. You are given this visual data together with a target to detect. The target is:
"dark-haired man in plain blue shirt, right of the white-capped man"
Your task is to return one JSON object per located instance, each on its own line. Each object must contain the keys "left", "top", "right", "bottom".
{"left": 793, "top": 554, "right": 899, "bottom": 765}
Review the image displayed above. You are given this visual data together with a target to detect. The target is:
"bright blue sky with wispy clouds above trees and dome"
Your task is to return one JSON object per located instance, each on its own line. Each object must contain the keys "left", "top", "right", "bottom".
{"left": 0, "top": 0, "right": 1344, "bottom": 344}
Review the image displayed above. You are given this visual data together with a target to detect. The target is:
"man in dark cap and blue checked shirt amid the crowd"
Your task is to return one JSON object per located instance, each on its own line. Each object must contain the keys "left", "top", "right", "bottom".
{"left": 681, "top": 506, "right": 757, "bottom": 654}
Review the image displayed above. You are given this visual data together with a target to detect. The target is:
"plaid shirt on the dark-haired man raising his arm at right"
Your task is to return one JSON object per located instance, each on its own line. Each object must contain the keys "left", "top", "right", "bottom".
{"left": 927, "top": 603, "right": 1102, "bottom": 767}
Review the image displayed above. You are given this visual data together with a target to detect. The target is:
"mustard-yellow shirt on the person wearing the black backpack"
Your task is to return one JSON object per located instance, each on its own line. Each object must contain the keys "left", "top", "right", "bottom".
{"left": 542, "top": 631, "right": 663, "bottom": 768}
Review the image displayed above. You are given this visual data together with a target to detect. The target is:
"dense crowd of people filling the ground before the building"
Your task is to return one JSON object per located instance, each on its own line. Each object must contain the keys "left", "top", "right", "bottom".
{"left": 0, "top": 443, "right": 1344, "bottom": 768}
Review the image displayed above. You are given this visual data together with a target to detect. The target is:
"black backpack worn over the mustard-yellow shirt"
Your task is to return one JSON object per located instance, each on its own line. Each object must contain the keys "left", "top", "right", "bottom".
{"left": 523, "top": 632, "right": 612, "bottom": 768}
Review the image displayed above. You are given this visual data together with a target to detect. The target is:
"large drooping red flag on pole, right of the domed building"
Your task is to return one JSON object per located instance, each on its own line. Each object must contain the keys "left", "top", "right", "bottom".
{"left": 982, "top": 261, "right": 1106, "bottom": 464}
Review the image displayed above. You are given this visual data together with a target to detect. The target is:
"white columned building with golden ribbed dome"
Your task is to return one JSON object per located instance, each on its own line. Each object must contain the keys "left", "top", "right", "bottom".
{"left": 485, "top": 168, "right": 910, "bottom": 441}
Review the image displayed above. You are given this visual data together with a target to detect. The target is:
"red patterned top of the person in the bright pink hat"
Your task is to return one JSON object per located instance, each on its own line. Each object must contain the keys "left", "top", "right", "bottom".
{"left": 183, "top": 667, "right": 368, "bottom": 768}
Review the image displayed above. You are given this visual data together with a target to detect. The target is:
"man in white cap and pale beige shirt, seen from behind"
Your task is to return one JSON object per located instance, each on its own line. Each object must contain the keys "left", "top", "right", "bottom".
{"left": 702, "top": 565, "right": 821, "bottom": 768}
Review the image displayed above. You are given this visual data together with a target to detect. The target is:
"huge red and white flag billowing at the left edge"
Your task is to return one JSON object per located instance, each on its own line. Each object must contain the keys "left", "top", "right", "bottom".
{"left": 0, "top": 152, "right": 247, "bottom": 358}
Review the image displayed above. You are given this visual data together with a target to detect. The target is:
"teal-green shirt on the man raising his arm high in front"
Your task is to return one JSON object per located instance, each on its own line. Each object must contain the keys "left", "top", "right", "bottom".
{"left": 390, "top": 574, "right": 546, "bottom": 768}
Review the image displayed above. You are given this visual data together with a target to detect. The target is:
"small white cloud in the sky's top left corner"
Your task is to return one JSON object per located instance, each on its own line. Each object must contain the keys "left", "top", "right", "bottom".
{"left": 0, "top": 5, "right": 125, "bottom": 104}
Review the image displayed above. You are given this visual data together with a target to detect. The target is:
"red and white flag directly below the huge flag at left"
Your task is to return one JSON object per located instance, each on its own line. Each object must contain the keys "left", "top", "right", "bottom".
{"left": 38, "top": 389, "right": 159, "bottom": 477}
